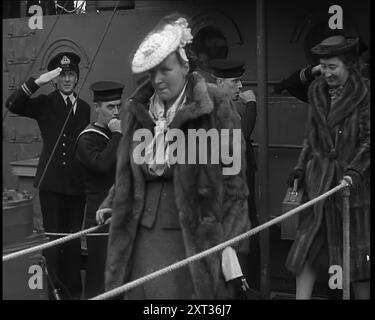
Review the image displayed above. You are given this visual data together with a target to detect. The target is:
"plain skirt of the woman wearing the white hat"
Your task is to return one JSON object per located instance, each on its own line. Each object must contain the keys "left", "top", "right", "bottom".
{"left": 125, "top": 182, "right": 194, "bottom": 300}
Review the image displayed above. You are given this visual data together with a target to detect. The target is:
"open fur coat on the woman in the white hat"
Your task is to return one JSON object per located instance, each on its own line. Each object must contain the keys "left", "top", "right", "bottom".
{"left": 101, "top": 72, "right": 250, "bottom": 299}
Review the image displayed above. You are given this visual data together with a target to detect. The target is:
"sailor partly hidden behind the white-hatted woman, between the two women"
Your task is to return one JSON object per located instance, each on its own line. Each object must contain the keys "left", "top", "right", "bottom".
{"left": 210, "top": 59, "right": 260, "bottom": 288}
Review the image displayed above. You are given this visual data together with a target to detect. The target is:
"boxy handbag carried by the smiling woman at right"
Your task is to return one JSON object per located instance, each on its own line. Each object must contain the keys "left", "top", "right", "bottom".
{"left": 281, "top": 179, "right": 303, "bottom": 240}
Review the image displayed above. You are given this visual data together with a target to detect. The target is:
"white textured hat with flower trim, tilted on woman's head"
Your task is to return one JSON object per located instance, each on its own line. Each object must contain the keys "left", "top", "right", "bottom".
{"left": 132, "top": 18, "right": 193, "bottom": 73}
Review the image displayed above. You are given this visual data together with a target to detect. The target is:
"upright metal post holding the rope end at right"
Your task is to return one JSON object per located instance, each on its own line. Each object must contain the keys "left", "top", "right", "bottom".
{"left": 342, "top": 182, "right": 350, "bottom": 300}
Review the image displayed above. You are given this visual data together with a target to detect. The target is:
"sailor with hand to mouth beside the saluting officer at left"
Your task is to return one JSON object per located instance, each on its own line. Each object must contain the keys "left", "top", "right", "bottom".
{"left": 76, "top": 81, "right": 124, "bottom": 298}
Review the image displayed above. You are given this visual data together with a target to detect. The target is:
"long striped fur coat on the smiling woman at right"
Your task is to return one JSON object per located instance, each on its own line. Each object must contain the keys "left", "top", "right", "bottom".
{"left": 286, "top": 70, "right": 370, "bottom": 280}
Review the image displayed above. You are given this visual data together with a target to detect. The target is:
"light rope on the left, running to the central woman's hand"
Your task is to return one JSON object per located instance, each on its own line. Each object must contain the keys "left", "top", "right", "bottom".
{"left": 3, "top": 218, "right": 111, "bottom": 262}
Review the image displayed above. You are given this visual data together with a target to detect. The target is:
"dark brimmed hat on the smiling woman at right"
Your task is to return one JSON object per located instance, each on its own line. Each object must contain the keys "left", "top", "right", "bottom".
{"left": 311, "top": 35, "right": 359, "bottom": 58}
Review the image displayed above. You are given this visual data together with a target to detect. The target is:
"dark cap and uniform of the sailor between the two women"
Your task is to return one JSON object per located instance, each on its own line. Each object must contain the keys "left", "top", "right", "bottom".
{"left": 210, "top": 59, "right": 260, "bottom": 288}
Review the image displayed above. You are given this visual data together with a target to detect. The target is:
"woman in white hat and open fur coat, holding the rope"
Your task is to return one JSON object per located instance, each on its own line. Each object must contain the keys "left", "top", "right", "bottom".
{"left": 97, "top": 17, "right": 250, "bottom": 299}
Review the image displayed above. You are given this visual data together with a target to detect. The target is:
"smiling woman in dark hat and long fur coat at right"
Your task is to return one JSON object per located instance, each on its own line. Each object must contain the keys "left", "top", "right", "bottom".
{"left": 286, "top": 36, "right": 370, "bottom": 299}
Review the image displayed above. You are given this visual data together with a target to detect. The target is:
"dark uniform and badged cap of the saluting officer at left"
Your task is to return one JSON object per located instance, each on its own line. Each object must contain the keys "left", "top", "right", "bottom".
{"left": 6, "top": 52, "right": 90, "bottom": 298}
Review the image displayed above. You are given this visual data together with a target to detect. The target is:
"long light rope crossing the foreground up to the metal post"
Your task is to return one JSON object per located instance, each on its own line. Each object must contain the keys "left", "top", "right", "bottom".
{"left": 90, "top": 180, "right": 349, "bottom": 300}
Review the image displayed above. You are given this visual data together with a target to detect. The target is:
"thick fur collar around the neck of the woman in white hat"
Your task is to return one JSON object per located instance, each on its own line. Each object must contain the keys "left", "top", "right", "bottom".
{"left": 128, "top": 72, "right": 214, "bottom": 130}
